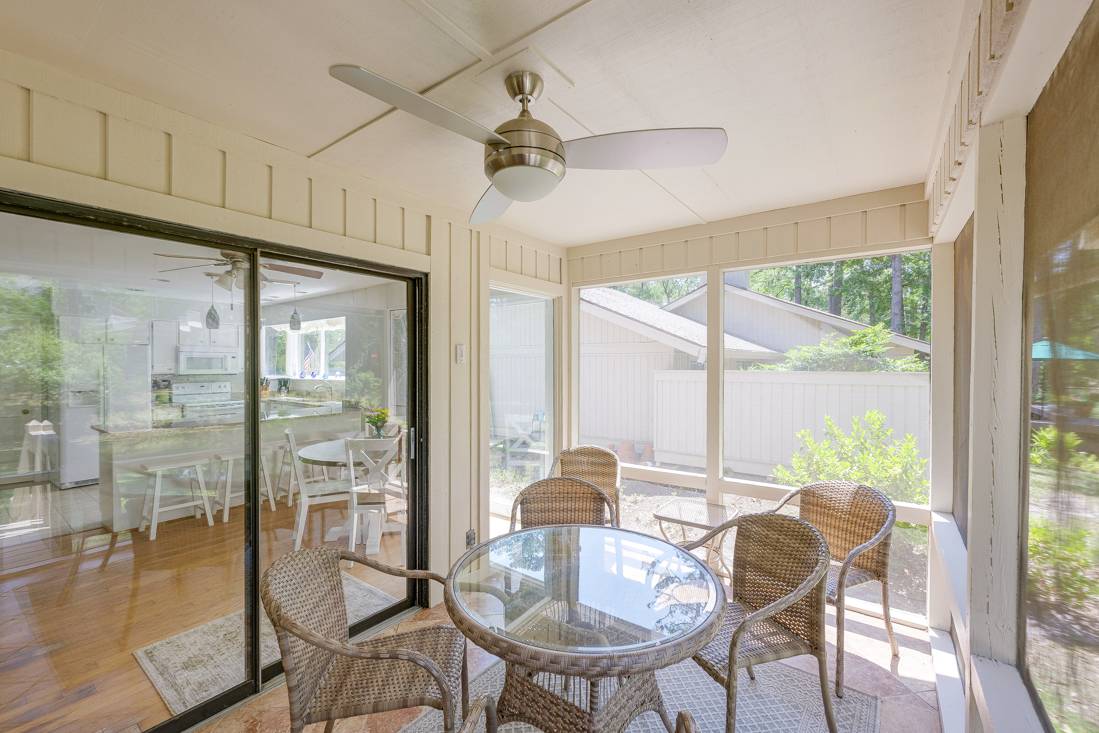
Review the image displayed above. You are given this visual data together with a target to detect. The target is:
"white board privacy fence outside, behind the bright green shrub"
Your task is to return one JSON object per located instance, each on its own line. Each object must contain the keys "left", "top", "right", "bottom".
{"left": 650, "top": 370, "right": 931, "bottom": 477}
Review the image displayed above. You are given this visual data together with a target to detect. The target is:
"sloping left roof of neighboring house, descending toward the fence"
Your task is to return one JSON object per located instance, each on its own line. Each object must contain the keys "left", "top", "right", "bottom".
{"left": 580, "top": 288, "right": 781, "bottom": 362}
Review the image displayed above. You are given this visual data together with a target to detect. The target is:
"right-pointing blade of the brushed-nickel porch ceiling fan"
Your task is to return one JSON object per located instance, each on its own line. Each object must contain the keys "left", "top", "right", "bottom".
{"left": 565, "top": 127, "right": 729, "bottom": 170}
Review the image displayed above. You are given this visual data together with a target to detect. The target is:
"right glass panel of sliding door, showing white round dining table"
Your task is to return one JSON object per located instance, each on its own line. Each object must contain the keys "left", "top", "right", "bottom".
{"left": 259, "top": 256, "right": 412, "bottom": 637}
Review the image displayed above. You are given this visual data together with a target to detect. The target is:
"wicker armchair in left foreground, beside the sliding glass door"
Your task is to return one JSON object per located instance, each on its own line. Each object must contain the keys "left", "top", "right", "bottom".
{"left": 259, "top": 547, "right": 468, "bottom": 733}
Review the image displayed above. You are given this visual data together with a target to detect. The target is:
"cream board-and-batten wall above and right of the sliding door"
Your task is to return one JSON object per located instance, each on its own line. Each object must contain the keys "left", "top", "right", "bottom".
{"left": 0, "top": 51, "right": 565, "bottom": 589}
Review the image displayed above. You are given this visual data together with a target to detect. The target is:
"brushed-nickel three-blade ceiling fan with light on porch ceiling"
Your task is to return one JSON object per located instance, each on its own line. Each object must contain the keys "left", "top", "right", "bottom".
{"left": 329, "top": 64, "right": 729, "bottom": 224}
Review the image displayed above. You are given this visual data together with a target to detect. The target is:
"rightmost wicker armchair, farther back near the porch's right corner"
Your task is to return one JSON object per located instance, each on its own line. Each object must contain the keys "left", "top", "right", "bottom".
{"left": 775, "top": 481, "right": 900, "bottom": 698}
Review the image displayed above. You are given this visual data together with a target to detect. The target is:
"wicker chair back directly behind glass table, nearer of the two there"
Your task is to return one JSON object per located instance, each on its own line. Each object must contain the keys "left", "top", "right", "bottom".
{"left": 509, "top": 478, "right": 618, "bottom": 532}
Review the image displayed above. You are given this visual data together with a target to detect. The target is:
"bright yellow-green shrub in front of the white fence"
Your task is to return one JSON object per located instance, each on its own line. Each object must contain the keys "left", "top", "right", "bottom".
{"left": 774, "top": 410, "right": 929, "bottom": 504}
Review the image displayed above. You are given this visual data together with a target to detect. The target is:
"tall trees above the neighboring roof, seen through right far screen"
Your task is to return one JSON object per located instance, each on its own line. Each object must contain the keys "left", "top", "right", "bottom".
{"left": 750, "top": 252, "right": 931, "bottom": 341}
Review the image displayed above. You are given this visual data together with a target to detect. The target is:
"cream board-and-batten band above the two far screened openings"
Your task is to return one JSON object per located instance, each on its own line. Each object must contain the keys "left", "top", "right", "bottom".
{"left": 568, "top": 185, "right": 930, "bottom": 285}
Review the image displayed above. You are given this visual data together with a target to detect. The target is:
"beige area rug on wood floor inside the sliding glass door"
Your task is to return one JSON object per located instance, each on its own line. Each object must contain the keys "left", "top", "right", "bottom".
{"left": 134, "top": 573, "right": 398, "bottom": 715}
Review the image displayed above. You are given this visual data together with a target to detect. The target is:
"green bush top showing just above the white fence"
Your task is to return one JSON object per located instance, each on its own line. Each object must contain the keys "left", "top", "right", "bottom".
{"left": 755, "top": 323, "right": 928, "bottom": 371}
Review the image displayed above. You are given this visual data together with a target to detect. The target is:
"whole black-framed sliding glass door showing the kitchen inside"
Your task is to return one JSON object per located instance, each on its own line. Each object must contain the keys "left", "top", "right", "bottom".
{"left": 0, "top": 195, "right": 426, "bottom": 730}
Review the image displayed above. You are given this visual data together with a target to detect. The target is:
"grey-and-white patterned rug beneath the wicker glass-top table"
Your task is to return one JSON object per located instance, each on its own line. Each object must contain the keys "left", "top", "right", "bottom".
{"left": 403, "top": 659, "right": 878, "bottom": 733}
